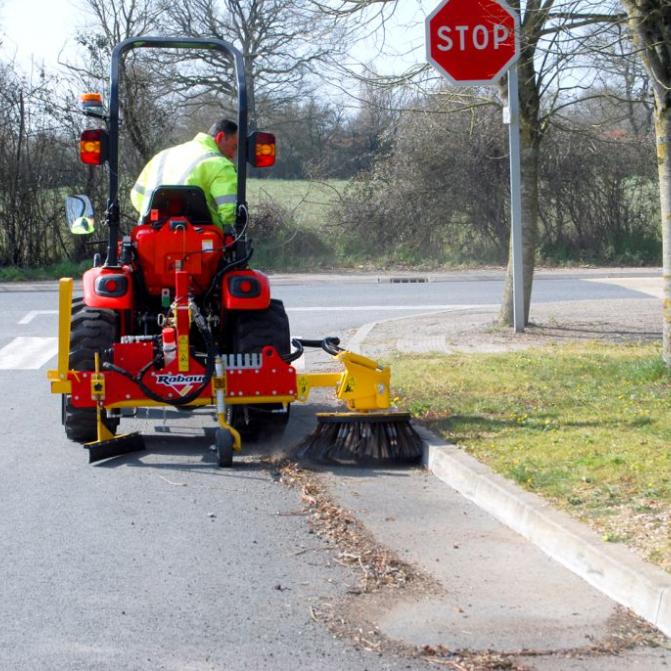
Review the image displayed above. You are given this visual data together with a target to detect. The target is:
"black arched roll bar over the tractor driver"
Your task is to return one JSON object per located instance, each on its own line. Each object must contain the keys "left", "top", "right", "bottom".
{"left": 105, "top": 36, "right": 248, "bottom": 266}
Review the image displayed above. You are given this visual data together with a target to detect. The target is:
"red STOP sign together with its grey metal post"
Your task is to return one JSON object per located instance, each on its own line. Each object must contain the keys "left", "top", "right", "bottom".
{"left": 426, "top": 0, "right": 524, "bottom": 333}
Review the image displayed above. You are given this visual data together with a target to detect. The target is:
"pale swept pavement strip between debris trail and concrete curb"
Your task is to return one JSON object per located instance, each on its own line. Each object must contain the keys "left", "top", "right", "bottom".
{"left": 318, "top": 469, "right": 671, "bottom": 671}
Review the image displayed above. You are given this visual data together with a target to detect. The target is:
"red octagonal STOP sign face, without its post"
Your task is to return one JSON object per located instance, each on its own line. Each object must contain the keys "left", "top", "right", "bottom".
{"left": 426, "top": 0, "right": 519, "bottom": 86}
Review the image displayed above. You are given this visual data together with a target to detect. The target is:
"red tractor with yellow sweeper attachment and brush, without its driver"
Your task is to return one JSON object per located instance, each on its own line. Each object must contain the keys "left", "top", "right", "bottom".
{"left": 48, "top": 37, "right": 422, "bottom": 466}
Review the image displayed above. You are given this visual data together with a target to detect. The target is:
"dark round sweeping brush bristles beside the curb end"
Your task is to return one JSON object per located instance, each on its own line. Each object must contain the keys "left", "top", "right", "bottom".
{"left": 297, "top": 413, "right": 423, "bottom": 465}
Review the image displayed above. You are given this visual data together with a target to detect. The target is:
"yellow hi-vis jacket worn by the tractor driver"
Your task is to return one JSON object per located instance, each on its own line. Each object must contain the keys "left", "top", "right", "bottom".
{"left": 130, "top": 133, "right": 238, "bottom": 228}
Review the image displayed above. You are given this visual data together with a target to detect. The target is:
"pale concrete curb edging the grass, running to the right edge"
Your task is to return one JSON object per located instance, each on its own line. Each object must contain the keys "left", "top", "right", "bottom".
{"left": 418, "top": 427, "right": 671, "bottom": 636}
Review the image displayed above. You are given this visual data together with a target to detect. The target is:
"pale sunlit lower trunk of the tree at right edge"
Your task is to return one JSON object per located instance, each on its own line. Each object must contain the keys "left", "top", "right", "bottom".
{"left": 655, "top": 105, "right": 671, "bottom": 366}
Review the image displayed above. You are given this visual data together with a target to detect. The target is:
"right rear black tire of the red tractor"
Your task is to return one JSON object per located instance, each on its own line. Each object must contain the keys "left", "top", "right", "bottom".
{"left": 228, "top": 299, "right": 291, "bottom": 440}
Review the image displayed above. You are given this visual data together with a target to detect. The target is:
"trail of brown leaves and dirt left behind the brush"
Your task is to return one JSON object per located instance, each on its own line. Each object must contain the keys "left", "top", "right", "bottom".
{"left": 276, "top": 461, "right": 665, "bottom": 671}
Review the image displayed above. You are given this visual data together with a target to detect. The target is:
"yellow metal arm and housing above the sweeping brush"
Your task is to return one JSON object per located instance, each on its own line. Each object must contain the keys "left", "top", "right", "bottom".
{"left": 296, "top": 351, "right": 391, "bottom": 412}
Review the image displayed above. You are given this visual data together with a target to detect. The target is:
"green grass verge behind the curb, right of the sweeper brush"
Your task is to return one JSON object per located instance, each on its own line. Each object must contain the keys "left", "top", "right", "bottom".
{"left": 394, "top": 343, "right": 671, "bottom": 571}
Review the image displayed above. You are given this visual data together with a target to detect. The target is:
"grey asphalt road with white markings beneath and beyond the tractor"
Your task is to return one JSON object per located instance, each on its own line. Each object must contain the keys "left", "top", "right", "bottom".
{"left": 0, "top": 270, "right": 660, "bottom": 671}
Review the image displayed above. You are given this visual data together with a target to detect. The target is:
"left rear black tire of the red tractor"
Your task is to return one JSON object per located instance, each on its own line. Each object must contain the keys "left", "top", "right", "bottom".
{"left": 61, "top": 306, "right": 119, "bottom": 443}
